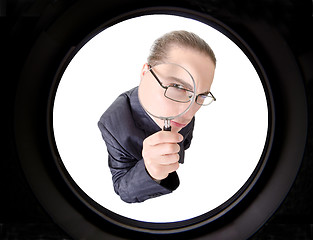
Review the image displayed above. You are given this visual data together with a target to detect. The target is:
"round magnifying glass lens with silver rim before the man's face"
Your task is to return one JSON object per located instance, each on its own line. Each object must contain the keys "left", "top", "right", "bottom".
{"left": 138, "top": 63, "right": 196, "bottom": 131}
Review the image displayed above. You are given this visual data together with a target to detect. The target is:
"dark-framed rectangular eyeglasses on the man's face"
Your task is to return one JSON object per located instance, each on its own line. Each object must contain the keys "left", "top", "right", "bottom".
{"left": 149, "top": 65, "right": 216, "bottom": 106}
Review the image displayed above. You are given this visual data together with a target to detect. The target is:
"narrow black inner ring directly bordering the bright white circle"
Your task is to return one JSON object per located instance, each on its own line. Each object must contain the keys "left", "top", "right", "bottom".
{"left": 48, "top": 8, "right": 275, "bottom": 233}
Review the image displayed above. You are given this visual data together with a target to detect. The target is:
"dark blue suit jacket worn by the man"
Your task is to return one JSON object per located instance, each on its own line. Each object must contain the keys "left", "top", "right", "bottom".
{"left": 98, "top": 87, "right": 194, "bottom": 203}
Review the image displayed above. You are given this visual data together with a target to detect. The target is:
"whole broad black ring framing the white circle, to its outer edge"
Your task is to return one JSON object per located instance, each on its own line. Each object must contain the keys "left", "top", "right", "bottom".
{"left": 15, "top": 2, "right": 307, "bottom": 239}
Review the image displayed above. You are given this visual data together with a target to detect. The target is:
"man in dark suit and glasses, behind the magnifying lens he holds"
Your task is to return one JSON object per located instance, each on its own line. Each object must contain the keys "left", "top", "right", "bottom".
{"left": 98, "top": 31, "right": 216, "bottom": 203}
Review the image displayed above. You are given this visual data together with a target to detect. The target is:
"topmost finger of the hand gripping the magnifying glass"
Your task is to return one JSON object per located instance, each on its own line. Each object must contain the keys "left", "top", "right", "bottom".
{"left": 146, "top": 131, "right": 184, "bottom": 146}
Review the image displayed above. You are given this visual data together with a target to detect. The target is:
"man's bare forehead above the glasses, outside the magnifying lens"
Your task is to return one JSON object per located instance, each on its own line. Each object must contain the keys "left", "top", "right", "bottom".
{"left": 167, "top": 45, "right": 215, "bottom": 92}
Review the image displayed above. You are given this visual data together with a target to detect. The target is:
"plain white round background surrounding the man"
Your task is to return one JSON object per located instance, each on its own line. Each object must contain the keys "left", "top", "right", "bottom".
{"left": 53, "top": 15, "right": 268, "bottom": 222}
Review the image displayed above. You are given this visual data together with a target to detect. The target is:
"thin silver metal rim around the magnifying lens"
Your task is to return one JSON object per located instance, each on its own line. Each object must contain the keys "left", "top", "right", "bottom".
{"left": 138, "top": 62, "right": 197, "bottom": 130}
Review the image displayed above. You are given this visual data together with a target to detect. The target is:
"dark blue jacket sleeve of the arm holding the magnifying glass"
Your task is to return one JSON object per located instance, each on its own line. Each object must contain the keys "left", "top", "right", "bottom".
{"left": 98, "top": 121, "right": 179, "bottom": 203}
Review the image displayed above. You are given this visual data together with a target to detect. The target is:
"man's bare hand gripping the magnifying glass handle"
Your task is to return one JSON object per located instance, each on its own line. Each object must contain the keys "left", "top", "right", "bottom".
{"left": 142, "top": 131, "right": 183, "bottom": 180}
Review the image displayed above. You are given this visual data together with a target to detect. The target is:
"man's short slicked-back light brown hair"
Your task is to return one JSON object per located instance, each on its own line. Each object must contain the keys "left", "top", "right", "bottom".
{"left": 147, "top": 30, "right": 216, "bottom": 66}
